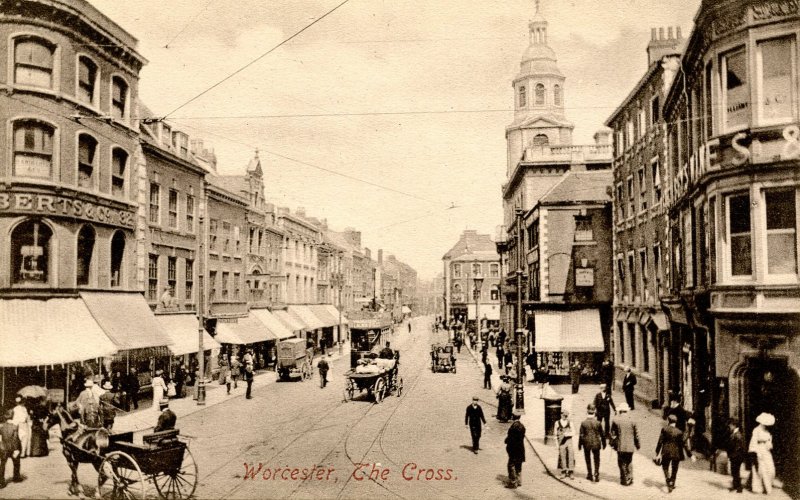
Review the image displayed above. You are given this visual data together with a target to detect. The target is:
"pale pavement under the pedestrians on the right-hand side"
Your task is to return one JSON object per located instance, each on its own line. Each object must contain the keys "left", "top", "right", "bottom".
{"left": 466, "top": 346, "right": 791, "bottom": 500}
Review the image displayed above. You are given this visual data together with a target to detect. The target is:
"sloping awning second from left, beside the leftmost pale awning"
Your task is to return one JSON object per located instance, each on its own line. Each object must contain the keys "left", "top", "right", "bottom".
{"left": 80, "top": 292, "right": 172, "bottom": 351}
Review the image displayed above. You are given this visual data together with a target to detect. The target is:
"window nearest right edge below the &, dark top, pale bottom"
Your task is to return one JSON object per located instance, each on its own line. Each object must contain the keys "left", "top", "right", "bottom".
{"left": 764, "top": 189, "right": 797, "bottom": 274}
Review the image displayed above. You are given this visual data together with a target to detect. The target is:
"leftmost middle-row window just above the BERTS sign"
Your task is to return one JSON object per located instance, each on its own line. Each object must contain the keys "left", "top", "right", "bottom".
{"left": 14, "top": 120, "right": 54, "bottom": 179}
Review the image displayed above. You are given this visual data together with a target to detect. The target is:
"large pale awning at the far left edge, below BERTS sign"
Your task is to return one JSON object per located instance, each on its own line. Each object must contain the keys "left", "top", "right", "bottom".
{"left": 0, "top": 298, "right": 117, "bottom": 366}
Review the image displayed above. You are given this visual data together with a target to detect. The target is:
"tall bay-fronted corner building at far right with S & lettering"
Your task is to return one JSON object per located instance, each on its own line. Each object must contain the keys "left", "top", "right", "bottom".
{"left": 662, "top": 0, "right": 800, "bottom": 495}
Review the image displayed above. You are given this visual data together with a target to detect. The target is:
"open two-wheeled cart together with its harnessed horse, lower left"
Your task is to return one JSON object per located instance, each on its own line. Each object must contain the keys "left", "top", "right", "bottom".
{"left": 54, "top": 408, "right": 198, "bottom": 500}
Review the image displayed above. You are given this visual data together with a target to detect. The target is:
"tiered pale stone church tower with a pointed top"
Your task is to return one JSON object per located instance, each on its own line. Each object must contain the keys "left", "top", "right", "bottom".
{"left": 506, "top": 0, "right": 575, "bottom": 175}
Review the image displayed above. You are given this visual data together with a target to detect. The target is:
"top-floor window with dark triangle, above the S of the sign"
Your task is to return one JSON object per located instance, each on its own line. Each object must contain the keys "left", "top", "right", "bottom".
{"left": 721, "top": 48, "right": 750, "bottom": 130}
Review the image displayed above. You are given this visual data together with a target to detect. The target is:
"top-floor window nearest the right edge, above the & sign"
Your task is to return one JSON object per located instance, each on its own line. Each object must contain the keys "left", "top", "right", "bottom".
{"left": 757, "top": 37, "right": 797, "bottom": 123}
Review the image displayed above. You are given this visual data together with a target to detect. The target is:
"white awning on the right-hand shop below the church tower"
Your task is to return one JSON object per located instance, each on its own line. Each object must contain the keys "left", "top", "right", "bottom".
{"left": 534, "top": 309, "right": 605, "bottom": 352}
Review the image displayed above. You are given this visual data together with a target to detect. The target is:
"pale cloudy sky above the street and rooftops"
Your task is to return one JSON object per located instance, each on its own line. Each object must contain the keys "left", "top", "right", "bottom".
{"left": 89, "top": 0, "right": 700, "bottom": 279}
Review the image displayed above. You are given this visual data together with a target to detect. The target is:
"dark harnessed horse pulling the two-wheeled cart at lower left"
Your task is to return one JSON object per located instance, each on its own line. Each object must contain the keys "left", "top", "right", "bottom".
{"left": 48, "top": 406, "right": 109, "bottom": 496}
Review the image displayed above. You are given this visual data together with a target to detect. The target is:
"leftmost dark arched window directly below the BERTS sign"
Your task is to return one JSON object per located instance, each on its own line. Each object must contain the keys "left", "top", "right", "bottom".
{"left": 11, "top": 219, "right": 53, "bottom": 285}
